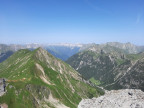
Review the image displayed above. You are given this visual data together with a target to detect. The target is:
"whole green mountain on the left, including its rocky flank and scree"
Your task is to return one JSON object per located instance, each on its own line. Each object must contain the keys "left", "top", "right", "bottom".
{"left": 0, "top": 48, "right": 104, "bottom": 108}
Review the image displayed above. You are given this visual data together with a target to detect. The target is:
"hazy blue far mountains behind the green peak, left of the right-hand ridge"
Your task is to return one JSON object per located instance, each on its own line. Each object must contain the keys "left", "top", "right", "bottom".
{"left": 0, "top": 44, "right": 83, "bottom": 62}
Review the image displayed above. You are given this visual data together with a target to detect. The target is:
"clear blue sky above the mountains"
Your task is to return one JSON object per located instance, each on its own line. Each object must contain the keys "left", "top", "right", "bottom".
{"left": 0, "top": 0, "right": 144, "bottom": 45}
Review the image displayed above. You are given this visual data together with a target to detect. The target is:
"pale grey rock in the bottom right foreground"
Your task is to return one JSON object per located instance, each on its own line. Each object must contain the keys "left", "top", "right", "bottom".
{"left": 78, "top": 89, "right": 144, "bottom": 108}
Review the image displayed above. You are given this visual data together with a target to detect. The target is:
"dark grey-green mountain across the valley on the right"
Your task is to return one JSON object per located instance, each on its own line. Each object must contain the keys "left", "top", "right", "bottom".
{"left": 66, "top": 45, "right": 144, "bottom": 91}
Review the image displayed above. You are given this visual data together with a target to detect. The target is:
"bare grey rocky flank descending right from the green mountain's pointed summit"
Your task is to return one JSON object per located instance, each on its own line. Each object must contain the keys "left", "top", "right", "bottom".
{"left": 34, "top": 48, "right": 79, "bottom": 79}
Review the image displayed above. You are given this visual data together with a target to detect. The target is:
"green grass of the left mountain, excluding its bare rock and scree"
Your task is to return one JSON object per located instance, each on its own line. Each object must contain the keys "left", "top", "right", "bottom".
{"left": 0, "top": 50, "right": 103, "bottom": 108}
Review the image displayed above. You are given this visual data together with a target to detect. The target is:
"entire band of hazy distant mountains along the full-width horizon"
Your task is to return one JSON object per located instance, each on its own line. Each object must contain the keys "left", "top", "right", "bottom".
{"left": 0, "top": 42, "right": 144, "bottom": 62}
